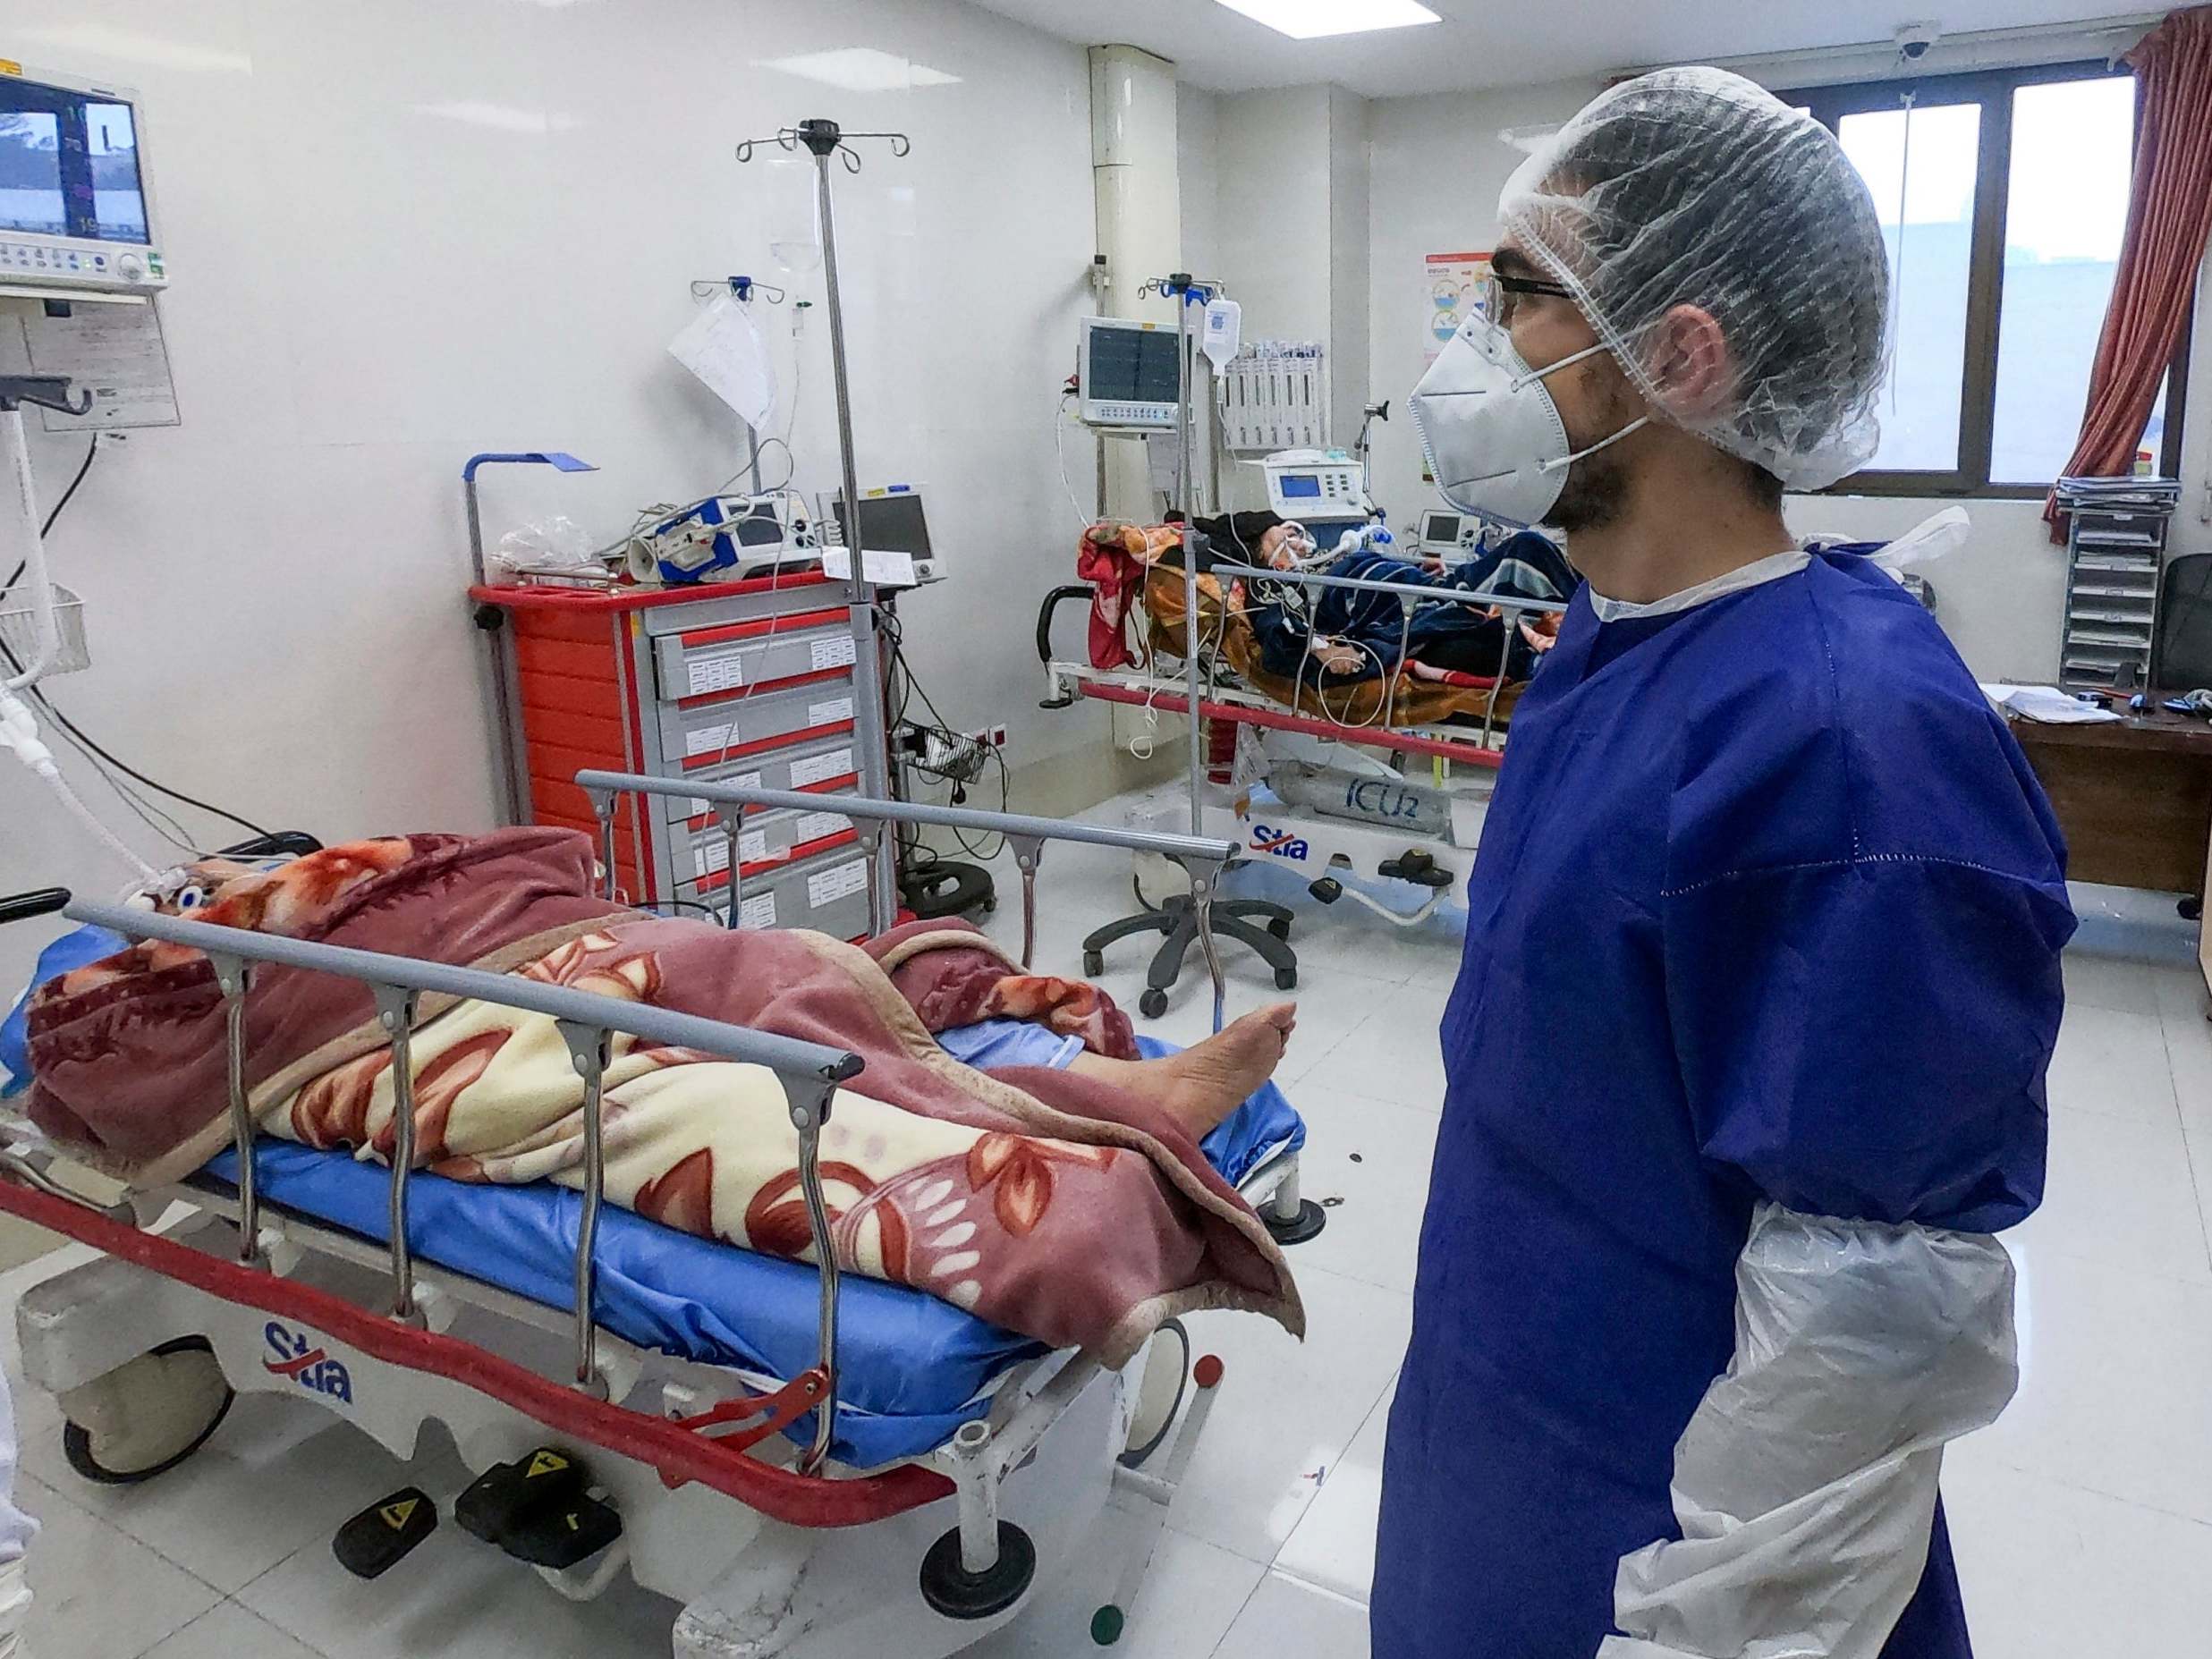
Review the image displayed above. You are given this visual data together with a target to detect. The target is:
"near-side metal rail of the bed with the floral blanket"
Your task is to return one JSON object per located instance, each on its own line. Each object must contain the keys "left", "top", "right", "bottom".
{"left": 62, "top": 902, "right": 862, "bottom": 1471}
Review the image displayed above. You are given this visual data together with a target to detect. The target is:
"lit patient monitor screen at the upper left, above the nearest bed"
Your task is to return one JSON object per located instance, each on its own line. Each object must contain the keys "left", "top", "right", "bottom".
{"left": 0, "top": 75, "right": 148, "bottom": 243}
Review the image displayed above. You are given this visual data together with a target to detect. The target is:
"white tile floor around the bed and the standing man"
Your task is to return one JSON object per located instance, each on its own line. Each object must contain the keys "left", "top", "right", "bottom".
{"left": 13, "top": 823, "right": 2212, "bottom": 1659}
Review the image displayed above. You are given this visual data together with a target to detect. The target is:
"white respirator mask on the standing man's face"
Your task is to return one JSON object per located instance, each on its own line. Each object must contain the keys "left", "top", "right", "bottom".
{"left": 1407, "top": 317, "right": 1650, "bottom": 529}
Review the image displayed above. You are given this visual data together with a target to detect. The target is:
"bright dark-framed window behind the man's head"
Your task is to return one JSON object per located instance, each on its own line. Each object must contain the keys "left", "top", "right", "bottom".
{"left": 1783, "top": 62, "right": 2185, "bottom": 495}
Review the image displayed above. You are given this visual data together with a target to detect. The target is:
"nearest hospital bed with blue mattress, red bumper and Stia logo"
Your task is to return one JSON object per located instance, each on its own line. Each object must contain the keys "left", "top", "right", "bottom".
{"left": 0, "top": 774, "right": 1303, "bottom": 1659}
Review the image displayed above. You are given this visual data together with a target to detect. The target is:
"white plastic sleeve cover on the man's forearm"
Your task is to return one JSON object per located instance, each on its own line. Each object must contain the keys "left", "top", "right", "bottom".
{"left": 1598, "top": 1203, "right": 2020, "bottom": 1659}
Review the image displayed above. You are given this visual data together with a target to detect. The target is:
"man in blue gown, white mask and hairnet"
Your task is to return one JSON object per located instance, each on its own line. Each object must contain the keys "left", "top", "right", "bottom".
{"left": 1374, "top": 71, "right": 2072, "bottom": 1659}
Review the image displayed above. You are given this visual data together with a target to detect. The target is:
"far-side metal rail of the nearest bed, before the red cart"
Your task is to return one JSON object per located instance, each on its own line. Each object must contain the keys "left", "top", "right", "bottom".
{"left": 575, "top": 772, "right": 1236, "bottom": 1031}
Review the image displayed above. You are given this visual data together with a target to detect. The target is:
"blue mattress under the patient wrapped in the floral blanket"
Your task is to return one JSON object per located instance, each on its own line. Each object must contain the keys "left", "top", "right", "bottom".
{"left": 206, "top": 1037, "right": 1305, "bottom": 1469}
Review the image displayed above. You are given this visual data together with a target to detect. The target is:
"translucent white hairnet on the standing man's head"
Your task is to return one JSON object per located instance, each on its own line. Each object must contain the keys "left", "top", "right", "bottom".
{"left": 1497, "top": 69, "right": 1889, "bottom": 489}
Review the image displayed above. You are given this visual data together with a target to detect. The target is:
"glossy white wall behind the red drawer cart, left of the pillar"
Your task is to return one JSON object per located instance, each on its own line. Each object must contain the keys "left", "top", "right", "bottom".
{"left": 0, "top": 0, "right": 1104, "bottom": 982}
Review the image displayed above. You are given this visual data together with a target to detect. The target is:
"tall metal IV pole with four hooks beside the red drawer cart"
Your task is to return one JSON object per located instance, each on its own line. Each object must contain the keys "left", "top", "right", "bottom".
{"left": 733, "top": 120, "right": 913, "bottom": 934}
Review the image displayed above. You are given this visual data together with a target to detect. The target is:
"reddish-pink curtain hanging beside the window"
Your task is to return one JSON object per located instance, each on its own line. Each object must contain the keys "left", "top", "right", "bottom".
{"left": 2044, "top": 6, "right": 2212, "bottom": 542}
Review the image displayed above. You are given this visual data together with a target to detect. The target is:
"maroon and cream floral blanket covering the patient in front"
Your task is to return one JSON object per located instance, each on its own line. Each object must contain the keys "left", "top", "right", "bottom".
{"left": 29, "top": 827, "right": 1303, "bottom": 1363}
